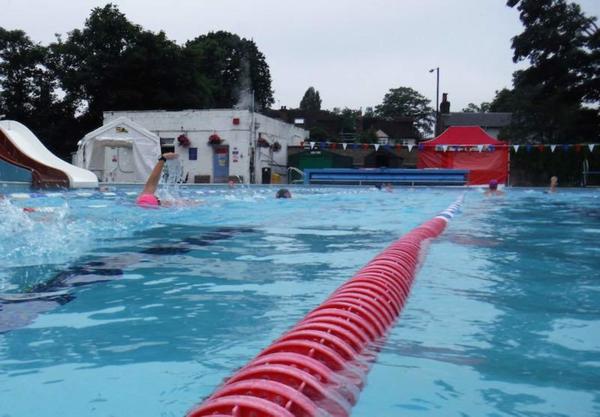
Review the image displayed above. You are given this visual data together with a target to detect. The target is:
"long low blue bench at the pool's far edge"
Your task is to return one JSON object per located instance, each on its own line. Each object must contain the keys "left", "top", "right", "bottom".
{"left": 304, "top": 168, "right": 469, "bottom": 185}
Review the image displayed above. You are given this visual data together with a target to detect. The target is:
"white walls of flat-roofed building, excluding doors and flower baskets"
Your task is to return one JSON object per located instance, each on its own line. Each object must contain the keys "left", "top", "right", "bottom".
{"left": 104, "top": 109, "right": 308, "bottom": 183}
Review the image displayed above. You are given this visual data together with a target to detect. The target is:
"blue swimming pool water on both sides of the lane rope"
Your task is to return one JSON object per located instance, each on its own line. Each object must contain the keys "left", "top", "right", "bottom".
{"left": 0, "top": 188, "right": 600, "bottom": 417}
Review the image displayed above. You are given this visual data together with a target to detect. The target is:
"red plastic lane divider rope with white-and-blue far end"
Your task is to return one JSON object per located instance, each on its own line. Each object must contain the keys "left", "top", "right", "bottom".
{"left": 187, "top": 196, "right": 463, "bottom": 417}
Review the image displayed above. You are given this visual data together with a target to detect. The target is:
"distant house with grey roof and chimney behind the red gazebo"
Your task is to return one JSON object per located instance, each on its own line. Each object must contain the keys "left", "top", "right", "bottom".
{"left": 440, "top": 93, "right": 512, "bottom": 138}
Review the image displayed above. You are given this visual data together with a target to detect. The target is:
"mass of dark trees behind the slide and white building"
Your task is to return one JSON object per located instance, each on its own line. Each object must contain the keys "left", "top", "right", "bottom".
{"left": 0, "top": 4, "right": 274, "bottom": 157}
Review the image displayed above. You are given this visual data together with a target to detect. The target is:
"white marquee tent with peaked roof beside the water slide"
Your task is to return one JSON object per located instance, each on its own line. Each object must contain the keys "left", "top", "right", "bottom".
{"left": 74, "top": 117, "right": 161, "bottom": 182}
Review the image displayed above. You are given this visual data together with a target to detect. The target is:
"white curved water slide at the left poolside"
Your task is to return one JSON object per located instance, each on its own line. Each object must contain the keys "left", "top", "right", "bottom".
{"left": 0, "top": 120, "right": 98, "bottom": 188}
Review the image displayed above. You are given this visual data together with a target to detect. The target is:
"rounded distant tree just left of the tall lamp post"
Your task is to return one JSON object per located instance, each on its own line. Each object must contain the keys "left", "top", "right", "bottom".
{"left": 375, "top": 87, "right": 435, "bottom": 134}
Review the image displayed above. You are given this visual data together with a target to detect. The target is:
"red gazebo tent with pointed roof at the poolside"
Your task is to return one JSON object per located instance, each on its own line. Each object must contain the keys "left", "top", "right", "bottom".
{"left": 417, "top": 126, "right": 509, "bottom": 185}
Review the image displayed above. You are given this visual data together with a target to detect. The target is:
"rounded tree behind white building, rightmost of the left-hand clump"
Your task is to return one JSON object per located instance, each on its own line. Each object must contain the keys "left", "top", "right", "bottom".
{"left": 185, "top": 31, "right": 275, "bottom": 108}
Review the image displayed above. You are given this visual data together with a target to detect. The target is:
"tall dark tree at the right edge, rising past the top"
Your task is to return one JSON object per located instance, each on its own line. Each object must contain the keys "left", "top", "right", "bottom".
{"left": 502, "top": 0, "right": 600, "bottom": 143}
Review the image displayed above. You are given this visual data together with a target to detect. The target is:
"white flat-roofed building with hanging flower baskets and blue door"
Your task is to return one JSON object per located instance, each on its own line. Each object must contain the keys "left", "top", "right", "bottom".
{"left": 104, "top": 109, "right": 309, "bottom": 183}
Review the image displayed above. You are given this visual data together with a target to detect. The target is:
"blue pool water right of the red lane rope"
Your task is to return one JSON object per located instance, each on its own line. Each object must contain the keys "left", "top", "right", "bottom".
{"left": 354, "top": 190, "right": 600, "bottom": 417}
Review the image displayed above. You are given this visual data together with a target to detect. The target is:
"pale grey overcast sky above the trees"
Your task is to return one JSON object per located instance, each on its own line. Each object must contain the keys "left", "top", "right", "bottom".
{"left": 0, "top": 0, "right": 600, "bottom": 111}
